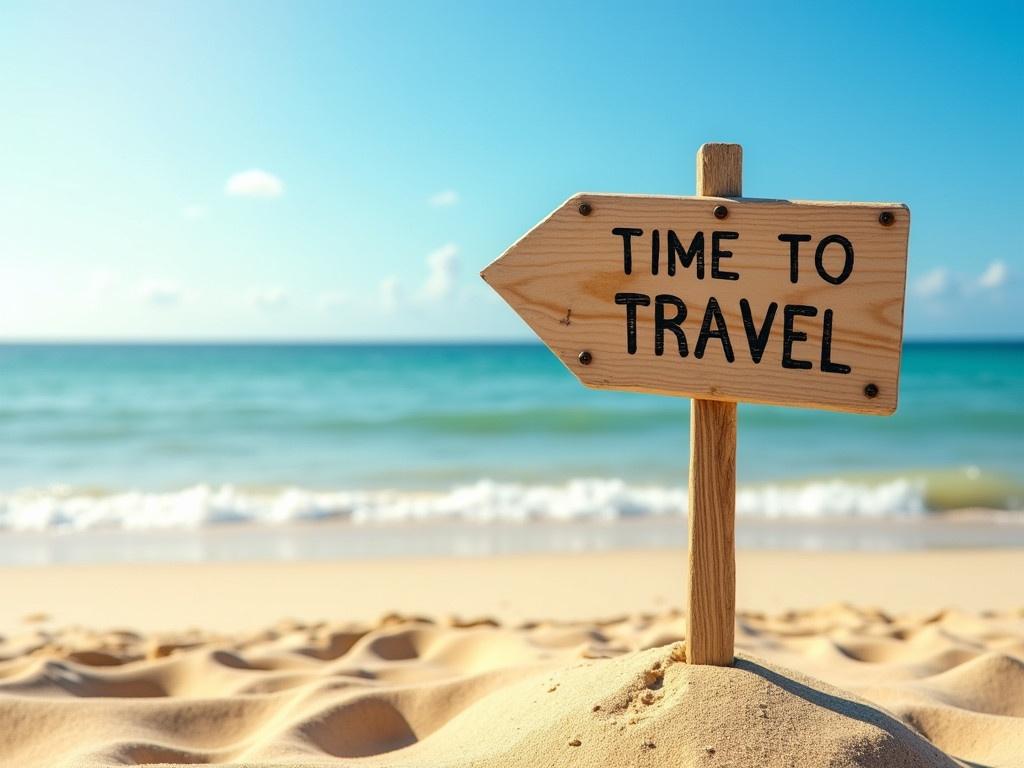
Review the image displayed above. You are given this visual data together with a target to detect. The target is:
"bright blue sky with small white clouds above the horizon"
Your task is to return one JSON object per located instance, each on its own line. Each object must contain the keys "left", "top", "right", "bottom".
{"left": 0, "top": 2, "right": 1024, "bottom": 339}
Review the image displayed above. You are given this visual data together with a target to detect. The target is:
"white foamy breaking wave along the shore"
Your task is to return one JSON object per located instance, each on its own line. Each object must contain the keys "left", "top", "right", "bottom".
{"left": 0, "top": 478, "right": 929, "bottom": 531}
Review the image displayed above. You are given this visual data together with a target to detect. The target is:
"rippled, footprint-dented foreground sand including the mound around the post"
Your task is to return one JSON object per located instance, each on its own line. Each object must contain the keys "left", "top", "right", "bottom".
{"left": 0, "top": 605, "right": 1024, "bottom": 768}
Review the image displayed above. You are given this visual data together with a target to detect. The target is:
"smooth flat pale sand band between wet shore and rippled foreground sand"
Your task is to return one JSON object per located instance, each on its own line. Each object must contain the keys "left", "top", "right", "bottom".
{"left": 0, "top": 549, "right": 1024, "bottom": 635}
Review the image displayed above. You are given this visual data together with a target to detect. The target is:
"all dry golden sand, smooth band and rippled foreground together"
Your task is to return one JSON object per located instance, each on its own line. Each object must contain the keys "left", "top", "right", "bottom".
{"left": 0, "top": 551, "right": 1024, "bottom": 768}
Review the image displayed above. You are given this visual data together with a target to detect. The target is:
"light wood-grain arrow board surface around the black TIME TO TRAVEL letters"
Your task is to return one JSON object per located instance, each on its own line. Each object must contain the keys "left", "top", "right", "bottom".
{"left": 482, "top": 180, "right": 909, "bottom": 414}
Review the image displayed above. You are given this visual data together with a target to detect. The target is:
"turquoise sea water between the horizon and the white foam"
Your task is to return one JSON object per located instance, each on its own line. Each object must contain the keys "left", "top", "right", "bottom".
{"left": 0, "top": 343, "right": 1024, "bottom": 526}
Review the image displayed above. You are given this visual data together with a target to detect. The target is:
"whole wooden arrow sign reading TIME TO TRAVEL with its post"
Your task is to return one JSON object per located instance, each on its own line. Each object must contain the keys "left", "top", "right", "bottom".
{"left": 481, "top": 143, "right": 910, "bottom": 665}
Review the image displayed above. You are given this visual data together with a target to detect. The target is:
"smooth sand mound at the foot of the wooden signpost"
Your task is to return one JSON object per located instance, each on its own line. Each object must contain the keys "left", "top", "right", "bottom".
{"left": 409, "top": 644, "right": 956, "bottom": 768}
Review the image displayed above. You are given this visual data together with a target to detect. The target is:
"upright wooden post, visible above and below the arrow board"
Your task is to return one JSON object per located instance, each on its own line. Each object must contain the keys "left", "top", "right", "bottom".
{"left": 686, "top": 144, "right": 743, "bottom": 667}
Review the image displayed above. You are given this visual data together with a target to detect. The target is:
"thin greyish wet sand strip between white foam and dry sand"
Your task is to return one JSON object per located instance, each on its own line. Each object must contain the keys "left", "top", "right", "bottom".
{"left": 0, "top": 510, "right": 1024, "bottom": 566}
